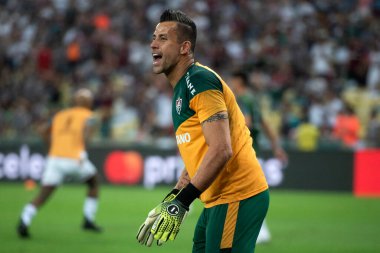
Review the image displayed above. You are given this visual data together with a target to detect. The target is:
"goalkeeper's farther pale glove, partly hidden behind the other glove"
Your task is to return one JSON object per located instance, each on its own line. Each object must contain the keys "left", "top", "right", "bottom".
{"left": 136, "top": 189, "right": 179, "bottom": 247}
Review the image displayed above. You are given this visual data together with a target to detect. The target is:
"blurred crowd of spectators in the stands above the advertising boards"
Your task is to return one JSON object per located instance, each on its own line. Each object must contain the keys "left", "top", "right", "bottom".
{"left": 0, "top": 0, "right": 380, "bottom": 149}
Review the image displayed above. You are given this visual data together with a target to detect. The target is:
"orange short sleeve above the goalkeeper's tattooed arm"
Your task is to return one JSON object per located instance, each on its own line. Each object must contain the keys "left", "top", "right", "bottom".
{"left": 190, "top": 90, "right": 227, "bottom": 122}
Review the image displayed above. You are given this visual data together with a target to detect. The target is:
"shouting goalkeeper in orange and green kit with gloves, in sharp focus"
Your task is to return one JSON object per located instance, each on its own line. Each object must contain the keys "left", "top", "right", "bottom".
{"left": 137, "top": 10, "right": 269, "bottom": 253}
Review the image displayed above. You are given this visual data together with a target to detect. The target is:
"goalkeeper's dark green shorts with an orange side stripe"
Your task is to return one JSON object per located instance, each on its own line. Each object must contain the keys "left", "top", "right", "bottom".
{"left": 193, "top": 190, "right": 269, "bottom": 253}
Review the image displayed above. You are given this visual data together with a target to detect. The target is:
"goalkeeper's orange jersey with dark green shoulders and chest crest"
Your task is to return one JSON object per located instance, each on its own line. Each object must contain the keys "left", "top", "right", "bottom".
{"left": 172, "top": 63, "right": 268, "bottom": 207}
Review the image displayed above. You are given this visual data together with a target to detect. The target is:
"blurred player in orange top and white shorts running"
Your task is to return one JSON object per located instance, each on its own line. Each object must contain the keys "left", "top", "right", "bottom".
{"left": 17, "top": 89, "right": 101, "bottom": 238}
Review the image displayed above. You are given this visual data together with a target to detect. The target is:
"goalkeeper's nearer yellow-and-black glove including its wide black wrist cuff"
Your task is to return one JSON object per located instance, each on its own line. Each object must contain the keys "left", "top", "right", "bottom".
{"left": 151, "top": 183, "right": 201, "bottom": 242}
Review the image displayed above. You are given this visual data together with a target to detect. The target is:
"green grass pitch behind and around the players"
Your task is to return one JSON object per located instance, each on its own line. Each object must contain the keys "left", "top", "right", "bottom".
{"left": 0, "top": 183, "right": 380, "bottom": 253}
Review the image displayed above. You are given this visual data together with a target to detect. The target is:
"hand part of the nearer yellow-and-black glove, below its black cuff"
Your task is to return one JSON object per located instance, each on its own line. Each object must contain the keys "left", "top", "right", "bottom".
{"left": 151, "top": 199, "right": 189, "bottom": 242}
